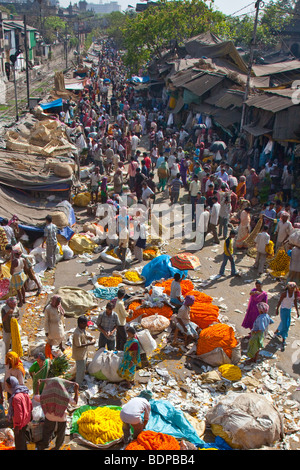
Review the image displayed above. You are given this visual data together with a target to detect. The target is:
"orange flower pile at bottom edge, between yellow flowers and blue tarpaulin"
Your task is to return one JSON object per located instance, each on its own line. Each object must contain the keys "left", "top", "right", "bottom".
{"left": 125, "top": 431, "right": 180, "bottom": 450}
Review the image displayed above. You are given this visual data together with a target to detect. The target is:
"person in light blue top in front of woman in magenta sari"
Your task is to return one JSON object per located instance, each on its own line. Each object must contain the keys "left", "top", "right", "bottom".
{"left": 247, "top": 302, "right": 274, "bottom": 362}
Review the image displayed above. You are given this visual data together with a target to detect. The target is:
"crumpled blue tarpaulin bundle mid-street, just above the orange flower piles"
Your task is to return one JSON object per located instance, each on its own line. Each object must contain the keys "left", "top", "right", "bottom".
{"left": 142, "top": 255, "right": 188, "bottom": 287}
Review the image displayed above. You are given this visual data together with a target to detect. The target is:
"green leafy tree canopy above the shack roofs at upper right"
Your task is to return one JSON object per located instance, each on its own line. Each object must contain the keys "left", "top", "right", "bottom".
{"left": 96, "top": 0, "right": 300, "bottom": 72}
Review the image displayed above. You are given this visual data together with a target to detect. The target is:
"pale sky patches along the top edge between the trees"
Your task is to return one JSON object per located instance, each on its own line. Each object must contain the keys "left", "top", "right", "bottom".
{"left": 59, "top": 0, "right": 255, "bottom": 15}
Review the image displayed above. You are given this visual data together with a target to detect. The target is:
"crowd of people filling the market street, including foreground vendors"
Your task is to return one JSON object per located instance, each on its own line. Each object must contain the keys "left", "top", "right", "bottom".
{"left": 0, "top": 38, "right": 300, "bottom": 449}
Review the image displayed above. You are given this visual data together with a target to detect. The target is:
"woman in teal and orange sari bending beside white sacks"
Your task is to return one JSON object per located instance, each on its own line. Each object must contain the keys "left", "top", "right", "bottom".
{"left": 118, "top": 326, "right": 141, "bottom": 388}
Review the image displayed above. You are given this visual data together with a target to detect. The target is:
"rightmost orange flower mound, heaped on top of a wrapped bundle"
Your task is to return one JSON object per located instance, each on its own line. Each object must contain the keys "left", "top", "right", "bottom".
{"left": 197, "top": 323, "right": 238, "bottom": 358}
